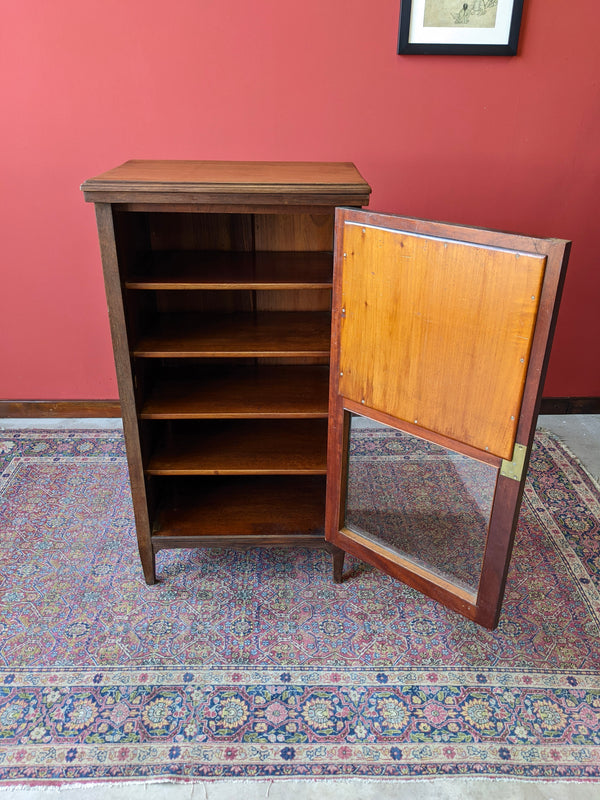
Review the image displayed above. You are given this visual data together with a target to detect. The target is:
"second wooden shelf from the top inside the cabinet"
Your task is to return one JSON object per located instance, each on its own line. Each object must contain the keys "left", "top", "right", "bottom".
{"left": 133, "top": 311, "right": 330, "bottom": 358}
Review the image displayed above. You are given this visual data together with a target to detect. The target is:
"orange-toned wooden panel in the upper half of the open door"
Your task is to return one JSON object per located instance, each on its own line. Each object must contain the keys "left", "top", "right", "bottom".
{"left": 340, "top": 223, "right": 546, "bottom": 460}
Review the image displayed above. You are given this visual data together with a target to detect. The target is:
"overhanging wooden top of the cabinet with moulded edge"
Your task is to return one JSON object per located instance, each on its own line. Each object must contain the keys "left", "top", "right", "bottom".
{"left": 81, "top": 161, "right": 371, "bottom": 202}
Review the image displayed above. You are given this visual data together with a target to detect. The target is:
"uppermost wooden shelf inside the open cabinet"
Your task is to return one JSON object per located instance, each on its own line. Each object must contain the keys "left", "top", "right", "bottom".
{"left": 125, "top": 250, "right": 332, "bottom": 290}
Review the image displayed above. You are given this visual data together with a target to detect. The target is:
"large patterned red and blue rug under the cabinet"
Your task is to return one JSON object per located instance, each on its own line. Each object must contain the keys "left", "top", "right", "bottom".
{"left": 0, "top": 430, "right": 600, "bottom": 785}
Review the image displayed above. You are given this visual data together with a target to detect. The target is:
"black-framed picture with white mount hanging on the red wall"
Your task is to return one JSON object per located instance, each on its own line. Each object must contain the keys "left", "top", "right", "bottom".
{"left": 398, "top": 0, "right": 523, "bottom": 56}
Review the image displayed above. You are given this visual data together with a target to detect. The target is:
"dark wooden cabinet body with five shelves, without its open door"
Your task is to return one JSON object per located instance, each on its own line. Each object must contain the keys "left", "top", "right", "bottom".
{"left": 82, "top": 161, "right": 370, "bottom": 583}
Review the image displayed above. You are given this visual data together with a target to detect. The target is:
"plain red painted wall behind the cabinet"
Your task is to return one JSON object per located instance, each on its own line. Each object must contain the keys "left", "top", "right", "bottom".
{"left": 0, "top": 0, "right": 600, "bottom": 399}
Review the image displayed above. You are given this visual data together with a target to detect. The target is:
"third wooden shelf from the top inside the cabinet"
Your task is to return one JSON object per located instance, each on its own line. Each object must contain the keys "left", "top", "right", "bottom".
{"left": 140, "top": 365, "right": 329, "bottom": 419}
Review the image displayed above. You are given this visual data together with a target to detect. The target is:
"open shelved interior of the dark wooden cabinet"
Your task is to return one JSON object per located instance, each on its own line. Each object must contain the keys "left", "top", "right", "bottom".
{"left": 113, "top": 206, "right": 334, "bottom": 547}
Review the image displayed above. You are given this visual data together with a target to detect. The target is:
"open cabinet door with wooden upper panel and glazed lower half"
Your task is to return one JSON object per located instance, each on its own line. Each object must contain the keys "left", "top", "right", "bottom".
{"left": 326, "top": 209, "right": 569, "bottom": 628}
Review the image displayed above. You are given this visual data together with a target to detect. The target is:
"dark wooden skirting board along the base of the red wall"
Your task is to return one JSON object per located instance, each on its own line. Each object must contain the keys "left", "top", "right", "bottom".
{"left": 0, "top": 397, "right": 600, "bottom": 419}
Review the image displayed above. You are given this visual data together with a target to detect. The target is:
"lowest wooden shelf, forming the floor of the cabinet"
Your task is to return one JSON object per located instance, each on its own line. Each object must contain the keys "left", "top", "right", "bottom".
{"left": 152, "top": 477, "right": 325, "bottom": 550}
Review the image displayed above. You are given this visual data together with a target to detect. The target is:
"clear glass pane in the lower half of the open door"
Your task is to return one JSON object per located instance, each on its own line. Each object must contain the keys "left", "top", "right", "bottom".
{"left": 345, "top": 414, "right": 498, "bottom": 591}
